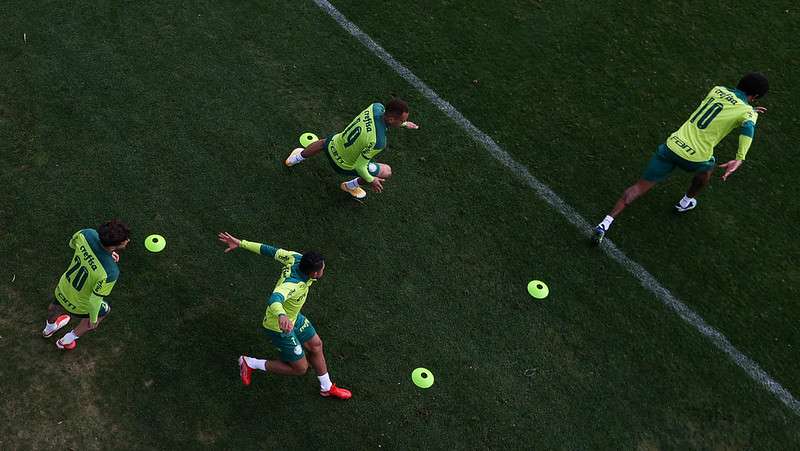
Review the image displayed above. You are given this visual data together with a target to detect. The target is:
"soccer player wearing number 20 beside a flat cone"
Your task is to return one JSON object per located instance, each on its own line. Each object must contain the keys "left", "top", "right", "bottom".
{"left": 42, "top": 219, "right": 131, "bottom": 350}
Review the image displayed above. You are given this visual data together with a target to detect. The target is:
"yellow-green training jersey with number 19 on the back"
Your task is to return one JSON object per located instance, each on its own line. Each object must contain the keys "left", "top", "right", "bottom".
{"left": 327, "top": 103, "right": 387, "bottom": 183}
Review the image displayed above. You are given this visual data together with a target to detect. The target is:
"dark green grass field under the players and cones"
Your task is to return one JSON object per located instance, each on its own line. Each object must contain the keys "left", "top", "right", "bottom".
{"left": 0, "top": 0, "right": 800, "bottom": 450}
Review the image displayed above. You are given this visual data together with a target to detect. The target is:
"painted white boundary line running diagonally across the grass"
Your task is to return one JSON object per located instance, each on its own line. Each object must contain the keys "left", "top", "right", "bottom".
{"left": 313, "top": 0, "right": 800, "bottom": 416}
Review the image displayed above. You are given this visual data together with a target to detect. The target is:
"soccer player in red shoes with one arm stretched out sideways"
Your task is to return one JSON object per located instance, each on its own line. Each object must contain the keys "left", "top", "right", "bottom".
{"left": 218, "top": 232, "right": 352, "bottom": 399}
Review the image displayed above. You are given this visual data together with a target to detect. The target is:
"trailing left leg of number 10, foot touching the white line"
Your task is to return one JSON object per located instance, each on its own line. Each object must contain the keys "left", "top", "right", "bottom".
{"left": 592, "top": 144, "right": 676, "bottom": 244}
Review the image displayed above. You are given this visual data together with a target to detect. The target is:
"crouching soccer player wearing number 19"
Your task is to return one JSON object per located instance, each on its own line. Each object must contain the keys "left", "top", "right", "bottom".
{"left": 286, "top": 99, "right": 419, "bottom": 199}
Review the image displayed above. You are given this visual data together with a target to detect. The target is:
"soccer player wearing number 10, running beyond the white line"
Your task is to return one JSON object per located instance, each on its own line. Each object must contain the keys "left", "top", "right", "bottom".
{"left": 592, "top": 72, "right": 769, "bottom": 244}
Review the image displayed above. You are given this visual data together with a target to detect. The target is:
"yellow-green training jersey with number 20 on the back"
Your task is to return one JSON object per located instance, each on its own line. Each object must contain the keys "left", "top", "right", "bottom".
{"left": 55, "top": 229, "right": 119, "bottom": 323}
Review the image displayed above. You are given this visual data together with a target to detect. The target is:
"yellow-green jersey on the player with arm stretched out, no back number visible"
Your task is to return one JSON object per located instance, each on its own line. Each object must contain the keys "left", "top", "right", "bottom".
{"left": 240, "top": 240, "right": 316, "bottom": 332}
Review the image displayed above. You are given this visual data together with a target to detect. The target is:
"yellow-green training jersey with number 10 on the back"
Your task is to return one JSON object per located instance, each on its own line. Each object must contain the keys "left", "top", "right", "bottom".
{"left": 667, "top": 86, "right": 758, "bottom": 162}
